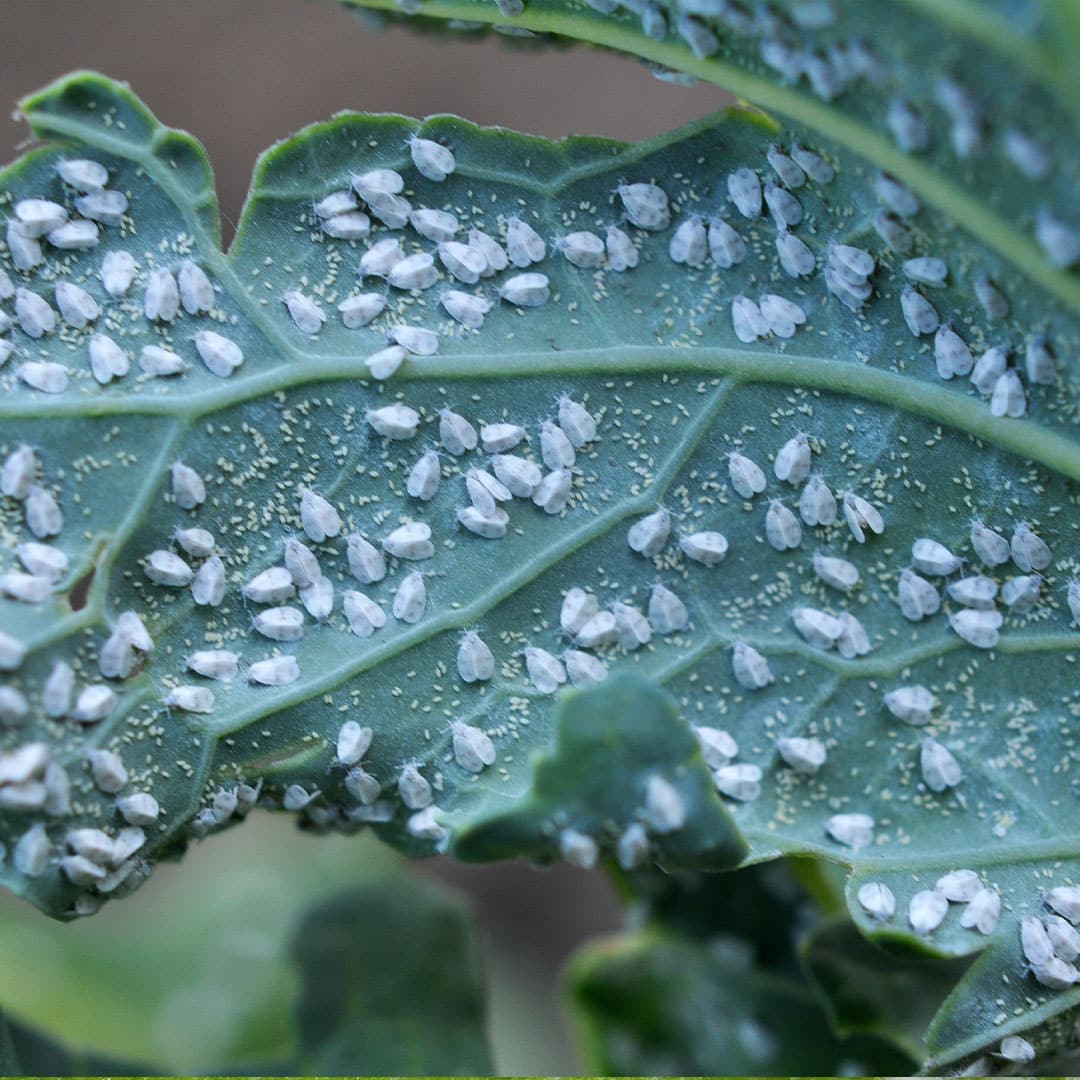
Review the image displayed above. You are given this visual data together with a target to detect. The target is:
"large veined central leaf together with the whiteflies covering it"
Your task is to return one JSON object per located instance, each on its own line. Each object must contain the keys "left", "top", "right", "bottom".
{"left": 0, "top": 61, "right": 1080, "bottom": 1059}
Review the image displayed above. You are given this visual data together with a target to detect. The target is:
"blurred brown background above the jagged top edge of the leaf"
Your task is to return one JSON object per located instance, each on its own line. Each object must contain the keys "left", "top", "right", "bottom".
{"left": 0, "top": 0, "right": 726, "bottom": 232}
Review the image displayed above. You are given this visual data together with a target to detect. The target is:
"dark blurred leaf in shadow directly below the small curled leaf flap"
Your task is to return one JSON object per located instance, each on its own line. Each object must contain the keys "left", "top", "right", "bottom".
{"left": 569, "top": 863, "right": 916, "bottom": 1076}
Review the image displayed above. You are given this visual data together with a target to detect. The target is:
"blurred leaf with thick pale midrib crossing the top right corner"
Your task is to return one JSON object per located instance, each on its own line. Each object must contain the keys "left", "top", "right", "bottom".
{"left": 346, "top": 0, "right": 1080, "bottom": 312}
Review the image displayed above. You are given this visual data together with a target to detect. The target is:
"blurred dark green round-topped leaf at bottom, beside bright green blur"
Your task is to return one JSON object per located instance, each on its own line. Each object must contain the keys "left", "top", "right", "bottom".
{"left": 293, "top": 881, "right": 492, "bottom": 1076}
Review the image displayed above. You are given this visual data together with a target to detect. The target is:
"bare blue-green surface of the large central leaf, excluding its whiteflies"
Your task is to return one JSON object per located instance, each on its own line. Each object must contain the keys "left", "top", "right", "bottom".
{"left": 0, "top": 65, "right": 1080, "bottom": 1056}
